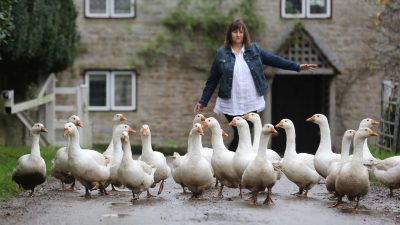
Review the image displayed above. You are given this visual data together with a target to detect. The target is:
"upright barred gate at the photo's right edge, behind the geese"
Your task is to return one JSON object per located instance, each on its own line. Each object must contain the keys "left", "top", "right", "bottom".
{"left": 376, "top": 80, "right": 400, "bottom": 152}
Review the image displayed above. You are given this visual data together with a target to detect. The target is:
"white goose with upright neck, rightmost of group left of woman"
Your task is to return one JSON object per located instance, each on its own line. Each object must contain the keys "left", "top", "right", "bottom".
{"left": 139, "top": 124, "right": 171, "bottom": 196}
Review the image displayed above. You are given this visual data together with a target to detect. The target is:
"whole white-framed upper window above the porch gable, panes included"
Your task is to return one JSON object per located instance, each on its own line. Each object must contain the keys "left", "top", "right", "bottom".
{"left": 281, "top": 0, "right": 331, "bottom": 18}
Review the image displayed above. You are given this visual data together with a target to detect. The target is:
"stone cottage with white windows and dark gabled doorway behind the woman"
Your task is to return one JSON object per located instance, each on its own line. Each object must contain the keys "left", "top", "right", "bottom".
{"left": 2, "top": 0, "right": 382, "bottom": 153}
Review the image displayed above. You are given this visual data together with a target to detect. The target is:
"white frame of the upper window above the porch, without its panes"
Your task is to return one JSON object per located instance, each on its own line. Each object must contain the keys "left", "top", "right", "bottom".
{"left": 281, "top": 0, "right": 332, "bottom": 19}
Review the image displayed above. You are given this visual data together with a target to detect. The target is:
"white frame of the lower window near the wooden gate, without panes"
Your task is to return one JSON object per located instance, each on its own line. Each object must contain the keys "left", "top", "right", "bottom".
{"left": 85, "top": 70, "right": 136, "bottom": 111}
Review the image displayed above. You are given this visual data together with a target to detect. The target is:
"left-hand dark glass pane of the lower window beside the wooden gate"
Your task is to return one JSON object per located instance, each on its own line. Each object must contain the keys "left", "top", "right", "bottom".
{"left": 89, "top": 74, "right": 107, "bottom": 106}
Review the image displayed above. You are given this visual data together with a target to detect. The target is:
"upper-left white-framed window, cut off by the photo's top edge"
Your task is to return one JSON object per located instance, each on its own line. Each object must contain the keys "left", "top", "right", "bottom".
{"left": 85, "top": 0, "right": 135, "bottom": 18}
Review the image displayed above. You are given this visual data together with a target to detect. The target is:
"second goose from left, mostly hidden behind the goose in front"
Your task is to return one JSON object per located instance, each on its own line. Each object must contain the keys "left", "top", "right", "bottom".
{"left": 51, "top": 115, "right": 83, "bottom": 191}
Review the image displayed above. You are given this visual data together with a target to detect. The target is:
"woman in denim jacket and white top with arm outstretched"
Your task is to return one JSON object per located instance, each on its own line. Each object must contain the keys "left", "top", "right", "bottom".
{"left": 194, "top": 19, "right": 317, "bottom": 151}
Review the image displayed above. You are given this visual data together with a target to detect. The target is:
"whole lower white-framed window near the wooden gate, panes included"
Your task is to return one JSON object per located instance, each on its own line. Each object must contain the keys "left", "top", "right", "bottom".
{"left": 85, "top": 71, "right": 136, "bottom": 111}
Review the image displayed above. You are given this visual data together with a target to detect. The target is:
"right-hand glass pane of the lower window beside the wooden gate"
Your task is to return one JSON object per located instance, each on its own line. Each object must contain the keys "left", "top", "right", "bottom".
{"left": 114, "top": 75, "right": 132, "bottom": 106}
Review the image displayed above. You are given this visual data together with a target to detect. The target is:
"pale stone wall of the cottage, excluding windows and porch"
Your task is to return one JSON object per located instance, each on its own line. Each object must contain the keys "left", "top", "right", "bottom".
{"left": 52, "top": 0, "right": 381, "bottom": 149}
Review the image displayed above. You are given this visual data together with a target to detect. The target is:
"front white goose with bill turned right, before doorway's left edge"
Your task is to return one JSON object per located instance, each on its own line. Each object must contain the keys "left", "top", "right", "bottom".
{"left": 242, "top": 124, "right": 278, "bottom": 204}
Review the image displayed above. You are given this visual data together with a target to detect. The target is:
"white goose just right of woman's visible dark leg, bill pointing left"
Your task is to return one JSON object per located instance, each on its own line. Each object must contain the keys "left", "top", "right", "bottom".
{"left": 229, "top": 116, "right": 256, "bottom": 197}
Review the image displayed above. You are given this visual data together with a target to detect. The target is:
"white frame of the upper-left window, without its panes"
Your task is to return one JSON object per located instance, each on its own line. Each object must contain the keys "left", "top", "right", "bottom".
{"left": 85, "top": 0, "right": 136, "bottom": 18}
